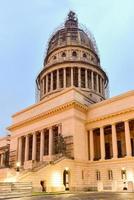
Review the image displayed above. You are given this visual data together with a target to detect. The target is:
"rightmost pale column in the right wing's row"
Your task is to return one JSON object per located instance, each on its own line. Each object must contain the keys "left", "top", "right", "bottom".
{"left": 124, "top": 121, "right": 132, "bottom": 156}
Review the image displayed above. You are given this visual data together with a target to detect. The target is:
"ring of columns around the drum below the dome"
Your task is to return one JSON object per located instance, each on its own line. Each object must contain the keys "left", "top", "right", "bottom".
{"left": 40, "top": 67, "right": 105, "bottom": 96}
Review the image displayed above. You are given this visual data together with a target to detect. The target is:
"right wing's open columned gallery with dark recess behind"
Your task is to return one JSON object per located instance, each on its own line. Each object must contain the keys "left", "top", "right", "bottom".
{"left": 88, "top": 119, "right": 134, "bottom": 161}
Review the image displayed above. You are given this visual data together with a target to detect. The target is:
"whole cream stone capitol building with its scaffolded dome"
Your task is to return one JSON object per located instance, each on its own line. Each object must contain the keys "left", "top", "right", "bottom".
{"left": 0, "top": 11, "right": 134, "bottom": 192}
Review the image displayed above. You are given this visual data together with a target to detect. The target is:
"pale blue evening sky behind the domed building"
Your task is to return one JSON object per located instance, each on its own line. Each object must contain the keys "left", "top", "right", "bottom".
{"left": 0, "top": 0, "right": 134, "bottom": 136}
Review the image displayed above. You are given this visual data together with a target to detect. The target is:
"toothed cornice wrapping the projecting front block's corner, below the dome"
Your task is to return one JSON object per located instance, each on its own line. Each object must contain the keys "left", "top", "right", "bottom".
{"left": 7, "top": 101, "right": 88, "bottom": 131}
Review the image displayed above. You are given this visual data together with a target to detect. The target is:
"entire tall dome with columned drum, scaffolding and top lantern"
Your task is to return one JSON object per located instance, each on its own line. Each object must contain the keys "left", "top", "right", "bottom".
{"left": 36, "top": 11, "right": 108, "bottom": 103}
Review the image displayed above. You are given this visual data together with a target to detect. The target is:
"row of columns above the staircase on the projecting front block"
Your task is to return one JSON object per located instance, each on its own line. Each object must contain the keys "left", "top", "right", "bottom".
{"left": 17, "top": 125, "right": 61, "bottom": 165}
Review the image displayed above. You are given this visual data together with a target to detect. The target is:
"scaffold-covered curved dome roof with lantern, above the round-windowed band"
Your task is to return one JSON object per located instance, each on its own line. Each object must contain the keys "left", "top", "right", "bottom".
{"left": 46, "top": 11, "right": 99, "bottom": 63}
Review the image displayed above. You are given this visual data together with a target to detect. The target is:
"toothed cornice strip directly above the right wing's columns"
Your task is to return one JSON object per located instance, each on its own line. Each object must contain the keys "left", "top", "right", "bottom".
{"left": 86, "top": 107, "right": 134, "bottom": 125}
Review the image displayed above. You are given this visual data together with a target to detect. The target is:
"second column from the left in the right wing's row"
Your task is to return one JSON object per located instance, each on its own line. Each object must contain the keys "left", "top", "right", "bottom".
{"left": 100, "top": 127, "right": 105, "bottom": 160}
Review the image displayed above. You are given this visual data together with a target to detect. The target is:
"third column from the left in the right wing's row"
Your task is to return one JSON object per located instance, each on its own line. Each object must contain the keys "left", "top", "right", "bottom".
{"left": 112, "top": 124, "right": 118, "bottom": 158}
